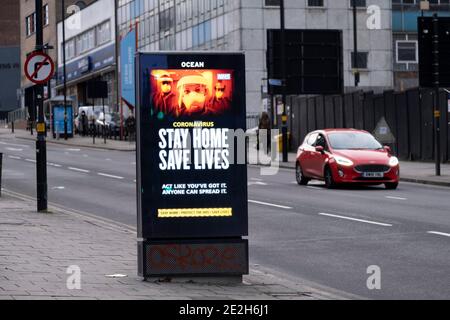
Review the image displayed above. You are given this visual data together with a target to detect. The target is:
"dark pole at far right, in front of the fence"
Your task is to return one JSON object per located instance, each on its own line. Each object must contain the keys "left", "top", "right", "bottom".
{"left": 433, "top": 13, "right": 441, "bottom": 176}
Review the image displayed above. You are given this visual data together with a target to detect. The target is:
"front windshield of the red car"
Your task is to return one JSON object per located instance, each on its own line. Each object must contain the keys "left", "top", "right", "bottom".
{"left": 328, "top": 132, "right": 383, "bottom": 150}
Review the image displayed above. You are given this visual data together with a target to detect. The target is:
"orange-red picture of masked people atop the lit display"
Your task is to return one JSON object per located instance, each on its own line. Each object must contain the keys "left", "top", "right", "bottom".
{"left": 151, "top": 69, "right": 233, "bottom": 118}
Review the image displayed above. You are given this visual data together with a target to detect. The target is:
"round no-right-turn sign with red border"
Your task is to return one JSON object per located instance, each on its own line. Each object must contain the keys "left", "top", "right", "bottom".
{"left": 24, "top": 51, "right": 55, "bottom": 84}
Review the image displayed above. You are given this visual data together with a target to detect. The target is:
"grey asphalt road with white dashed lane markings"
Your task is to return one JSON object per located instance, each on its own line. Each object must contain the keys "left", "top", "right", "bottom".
{"left": 0, "top": 137, "right": 450, "bottom": 299}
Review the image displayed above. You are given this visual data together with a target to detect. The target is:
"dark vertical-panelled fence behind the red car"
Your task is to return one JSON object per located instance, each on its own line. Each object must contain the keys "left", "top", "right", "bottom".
{"left": 278, "top": 88, "right": 450, "bottom": 162}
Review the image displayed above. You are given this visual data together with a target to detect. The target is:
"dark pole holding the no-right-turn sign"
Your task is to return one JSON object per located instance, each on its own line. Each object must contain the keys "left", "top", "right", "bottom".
{"left": 35, "top": 0, "right": 47, "bottom": 212}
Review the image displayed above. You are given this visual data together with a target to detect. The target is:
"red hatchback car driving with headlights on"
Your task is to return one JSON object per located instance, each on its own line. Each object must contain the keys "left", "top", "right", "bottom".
{"left": 295, "top": 129, "right": 400, "bottom": 189}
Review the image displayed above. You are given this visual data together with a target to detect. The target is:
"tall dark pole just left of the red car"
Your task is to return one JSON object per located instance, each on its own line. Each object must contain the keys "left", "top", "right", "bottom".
{"left": 280, "top": 0, "right": 289, "bottom": 162}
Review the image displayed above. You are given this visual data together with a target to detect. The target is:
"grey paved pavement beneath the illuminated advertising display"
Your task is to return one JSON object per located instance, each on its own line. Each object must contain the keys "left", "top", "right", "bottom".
{"left": 0, "top": 190, "right": 355, "bottom": 300}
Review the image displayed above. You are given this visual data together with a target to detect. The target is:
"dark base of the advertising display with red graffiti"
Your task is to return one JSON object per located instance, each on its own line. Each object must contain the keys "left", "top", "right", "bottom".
{"left": 138, "top": 238, "right": 249, "bottom": 283}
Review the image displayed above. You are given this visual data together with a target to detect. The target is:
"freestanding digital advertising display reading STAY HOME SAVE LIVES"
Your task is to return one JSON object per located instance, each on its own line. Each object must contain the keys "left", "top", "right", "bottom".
{"left": 136, "top": 52, "right": 248, "bottom": 279}
